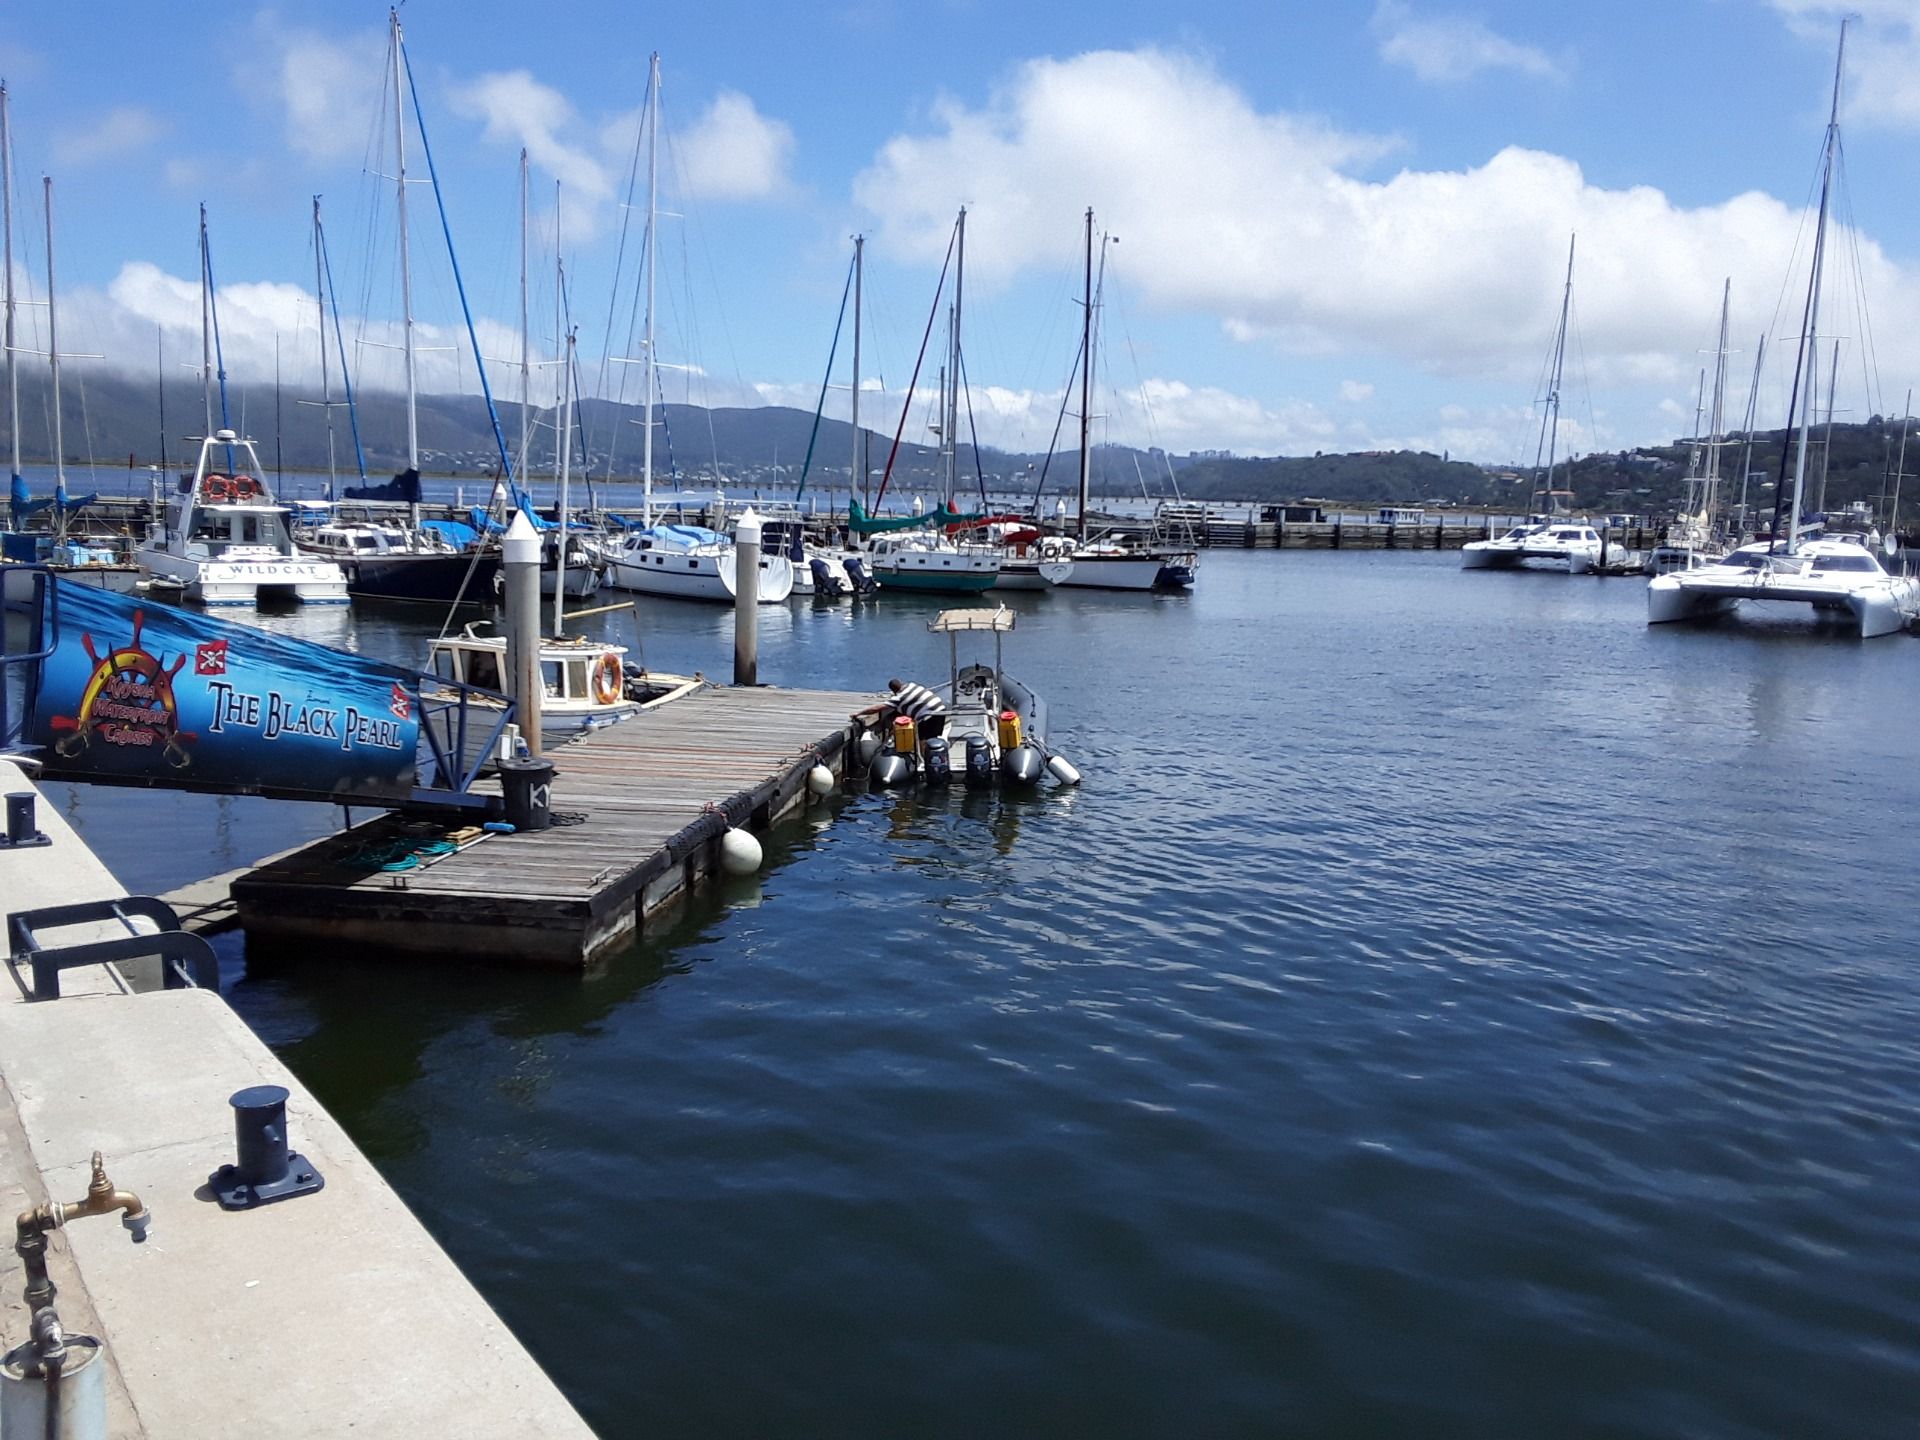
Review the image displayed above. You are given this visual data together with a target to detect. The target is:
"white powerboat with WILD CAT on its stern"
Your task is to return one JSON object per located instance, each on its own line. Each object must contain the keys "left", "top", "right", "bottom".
{"left": 138, "top": 430, "right": 348, "bottom": 605}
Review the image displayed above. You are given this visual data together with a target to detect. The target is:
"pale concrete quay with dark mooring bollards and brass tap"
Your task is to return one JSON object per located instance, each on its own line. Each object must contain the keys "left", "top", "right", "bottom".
{"left": 0, "top": 760, "right": 591, "bottom": 1440}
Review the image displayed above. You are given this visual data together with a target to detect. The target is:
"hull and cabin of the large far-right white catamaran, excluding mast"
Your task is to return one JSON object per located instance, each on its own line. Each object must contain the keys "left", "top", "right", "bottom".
{"left": 1647, "top": 536, "right": 1920, "bottom": 639}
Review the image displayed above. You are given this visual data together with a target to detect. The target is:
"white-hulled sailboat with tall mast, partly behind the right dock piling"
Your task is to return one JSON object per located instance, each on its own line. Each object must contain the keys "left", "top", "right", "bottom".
{"left": 601, "top": 54, "right": 793, "bottom": 605}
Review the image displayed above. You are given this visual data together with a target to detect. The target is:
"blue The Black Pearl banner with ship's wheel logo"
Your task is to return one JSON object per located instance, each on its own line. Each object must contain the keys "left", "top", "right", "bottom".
{"left": 27, "top": 580, "right": 420, "bottom": 803}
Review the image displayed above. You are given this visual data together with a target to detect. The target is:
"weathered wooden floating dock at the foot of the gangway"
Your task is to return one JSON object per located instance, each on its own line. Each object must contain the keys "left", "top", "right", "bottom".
{"left": 232, "top": 685, "right": 876, "bottom": 968}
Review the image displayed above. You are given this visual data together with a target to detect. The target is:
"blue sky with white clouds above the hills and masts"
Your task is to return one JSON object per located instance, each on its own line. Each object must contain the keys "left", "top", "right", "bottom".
{"left": 0, "top": 0, "right": 1920, "bottom": 463}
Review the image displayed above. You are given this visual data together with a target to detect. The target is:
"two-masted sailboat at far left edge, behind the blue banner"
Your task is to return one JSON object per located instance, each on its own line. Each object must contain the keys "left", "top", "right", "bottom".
{"left": 0, "top": 83, "right": 140, "bottom": 593}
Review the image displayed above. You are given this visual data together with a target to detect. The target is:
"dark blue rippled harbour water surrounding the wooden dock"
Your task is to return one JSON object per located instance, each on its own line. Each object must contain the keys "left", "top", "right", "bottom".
{"left": 41, "top": 553, "right": 1920, "bottom": 1436}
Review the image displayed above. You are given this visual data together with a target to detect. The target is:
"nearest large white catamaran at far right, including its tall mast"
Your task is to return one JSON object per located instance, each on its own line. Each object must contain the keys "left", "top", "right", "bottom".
{"left": 1647, "top": 21, "right": 1920, "bottom": 639}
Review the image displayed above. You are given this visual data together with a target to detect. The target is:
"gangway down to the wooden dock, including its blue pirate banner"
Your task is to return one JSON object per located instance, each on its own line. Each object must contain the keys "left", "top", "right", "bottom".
{"left": 0, "top": 564, "right": 515, "bottom": 812}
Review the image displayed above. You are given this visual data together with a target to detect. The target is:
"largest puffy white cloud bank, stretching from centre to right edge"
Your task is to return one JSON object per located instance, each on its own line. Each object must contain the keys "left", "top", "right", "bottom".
{"left": 854, "top": 50, "right": 1920, "bottom": 403}
